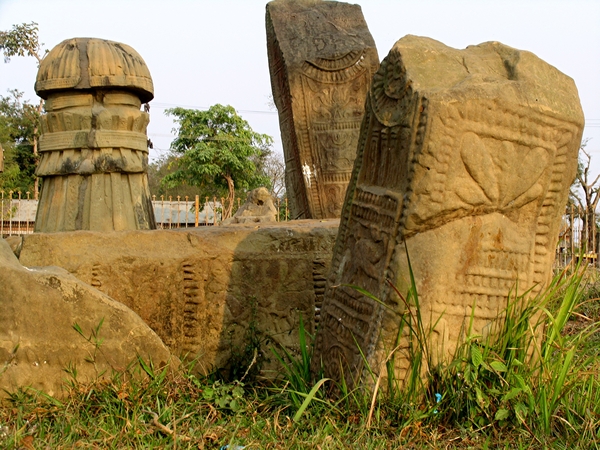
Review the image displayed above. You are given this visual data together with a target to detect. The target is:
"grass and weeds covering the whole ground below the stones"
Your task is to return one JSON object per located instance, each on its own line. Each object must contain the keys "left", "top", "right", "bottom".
{"left": 0, "top": 266, "right": 600, "bottom": 449}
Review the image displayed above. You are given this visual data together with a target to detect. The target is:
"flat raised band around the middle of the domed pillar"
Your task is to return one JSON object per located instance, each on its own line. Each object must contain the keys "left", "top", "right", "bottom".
{"left": 40, "top": 130, "right": 148, "bottom": 152}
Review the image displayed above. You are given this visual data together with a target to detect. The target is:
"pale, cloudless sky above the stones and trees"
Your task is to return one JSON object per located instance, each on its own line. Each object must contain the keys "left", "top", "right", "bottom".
{"left": 0, "top": 0, "right": 600, "bottom": 173}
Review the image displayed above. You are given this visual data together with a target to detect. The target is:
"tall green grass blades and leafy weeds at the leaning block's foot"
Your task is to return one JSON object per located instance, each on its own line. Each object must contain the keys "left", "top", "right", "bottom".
{"left": 270, "top": 262, "right": 600, "bottom": 444}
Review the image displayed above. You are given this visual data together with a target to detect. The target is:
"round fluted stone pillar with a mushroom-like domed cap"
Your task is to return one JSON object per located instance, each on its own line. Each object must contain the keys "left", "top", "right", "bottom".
{"left": 35, "top": 38, "right": 156, "bottom": 232}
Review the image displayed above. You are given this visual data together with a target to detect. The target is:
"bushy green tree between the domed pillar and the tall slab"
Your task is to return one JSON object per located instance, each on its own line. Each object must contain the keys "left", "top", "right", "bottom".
{"left": 162, "top": 104, "right": 273, "bottom": 219}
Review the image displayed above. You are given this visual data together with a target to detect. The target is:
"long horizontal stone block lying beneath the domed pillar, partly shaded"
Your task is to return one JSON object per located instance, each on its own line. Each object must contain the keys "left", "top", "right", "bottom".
{"left": 21, "top": 220, "right": 338, "bottom": 371}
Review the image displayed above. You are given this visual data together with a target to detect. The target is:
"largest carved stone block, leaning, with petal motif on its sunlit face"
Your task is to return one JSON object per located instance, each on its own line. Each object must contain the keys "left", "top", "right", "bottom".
{"left": 316, "top": 36, "right": 584, "bottom": 386}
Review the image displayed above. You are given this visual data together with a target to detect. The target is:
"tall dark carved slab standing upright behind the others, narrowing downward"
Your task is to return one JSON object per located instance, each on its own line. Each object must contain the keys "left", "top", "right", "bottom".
{"left": 266, "top": 0, "right": 379, "bottom": 219}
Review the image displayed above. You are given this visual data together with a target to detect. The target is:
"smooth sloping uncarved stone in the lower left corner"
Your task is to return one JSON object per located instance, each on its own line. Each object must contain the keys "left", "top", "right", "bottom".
{"left": 0, "top": 239, "right": 171, "bottom": 396}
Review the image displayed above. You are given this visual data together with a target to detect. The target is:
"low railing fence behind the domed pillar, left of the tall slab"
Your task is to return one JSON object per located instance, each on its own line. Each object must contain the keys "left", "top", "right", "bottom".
{"left": 0, "top": 191, "right": 289, "bottom": 237}
